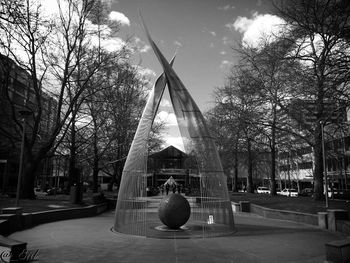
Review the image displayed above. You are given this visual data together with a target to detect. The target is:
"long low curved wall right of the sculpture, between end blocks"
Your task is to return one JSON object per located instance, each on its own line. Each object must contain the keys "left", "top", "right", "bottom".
{"left": 250, "top": 204, "right": 318, "bottom": 226}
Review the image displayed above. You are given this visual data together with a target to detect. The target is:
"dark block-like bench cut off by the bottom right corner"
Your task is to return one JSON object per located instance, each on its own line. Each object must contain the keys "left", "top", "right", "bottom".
{"left": 326, "top": 238, "right": 350, "bottom": 263}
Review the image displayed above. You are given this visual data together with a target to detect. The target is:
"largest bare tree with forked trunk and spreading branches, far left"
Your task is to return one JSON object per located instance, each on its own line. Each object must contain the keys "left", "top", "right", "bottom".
{"left": 0, "top": 0, "right": 126, "bottom": 198}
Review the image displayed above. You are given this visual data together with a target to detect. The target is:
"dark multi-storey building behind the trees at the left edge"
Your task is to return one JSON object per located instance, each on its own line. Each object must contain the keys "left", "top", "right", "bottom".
{"left": 0, "top": 54, "right": 57, "bottom": 193}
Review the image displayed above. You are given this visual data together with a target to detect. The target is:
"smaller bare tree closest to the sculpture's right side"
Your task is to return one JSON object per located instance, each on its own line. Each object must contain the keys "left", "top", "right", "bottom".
{"left": 215, "top": 65, "right": 261, "bottom": 193}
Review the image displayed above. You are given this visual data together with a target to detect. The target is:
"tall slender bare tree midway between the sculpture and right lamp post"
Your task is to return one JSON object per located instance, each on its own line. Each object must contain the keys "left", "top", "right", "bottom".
{"left": 235, "top": 38, "right": 300, "bottom": 195}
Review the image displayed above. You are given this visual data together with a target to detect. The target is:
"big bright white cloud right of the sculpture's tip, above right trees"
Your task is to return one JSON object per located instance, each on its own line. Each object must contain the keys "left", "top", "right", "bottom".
{"left": 225, "top": 12, "right": 284, "bottom": 47}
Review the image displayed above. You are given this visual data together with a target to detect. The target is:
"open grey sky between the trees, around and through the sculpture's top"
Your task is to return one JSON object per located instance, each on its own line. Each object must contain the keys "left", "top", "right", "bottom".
{"left": 104, "top": 0, "right": 282, "bottom": 150}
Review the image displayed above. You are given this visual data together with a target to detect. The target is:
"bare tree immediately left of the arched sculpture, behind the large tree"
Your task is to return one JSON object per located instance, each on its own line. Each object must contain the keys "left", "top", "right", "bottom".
{"left": 78, "top": 61, "right": 154, "bottom": 192}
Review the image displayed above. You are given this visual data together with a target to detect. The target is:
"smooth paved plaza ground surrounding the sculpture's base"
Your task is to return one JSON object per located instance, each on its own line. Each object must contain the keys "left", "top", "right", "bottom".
{"left": 10, "top": 211, "right": 344, "bottom": 263}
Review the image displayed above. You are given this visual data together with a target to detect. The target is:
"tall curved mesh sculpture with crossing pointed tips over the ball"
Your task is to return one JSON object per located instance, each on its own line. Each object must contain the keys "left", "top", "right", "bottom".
{"left": 114, "top": 17, "right": 234, "bottom": 237}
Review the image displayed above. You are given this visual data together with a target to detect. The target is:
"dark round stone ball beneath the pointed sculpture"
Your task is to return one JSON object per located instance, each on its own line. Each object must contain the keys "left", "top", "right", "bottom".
{"left": 158, "top": 194, "right": 191, "bottom": 229}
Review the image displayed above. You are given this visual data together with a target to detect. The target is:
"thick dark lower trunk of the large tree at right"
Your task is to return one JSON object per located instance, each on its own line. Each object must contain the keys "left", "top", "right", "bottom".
{"left": 313, "top": 124, "right": 324, "bottom": 200}
